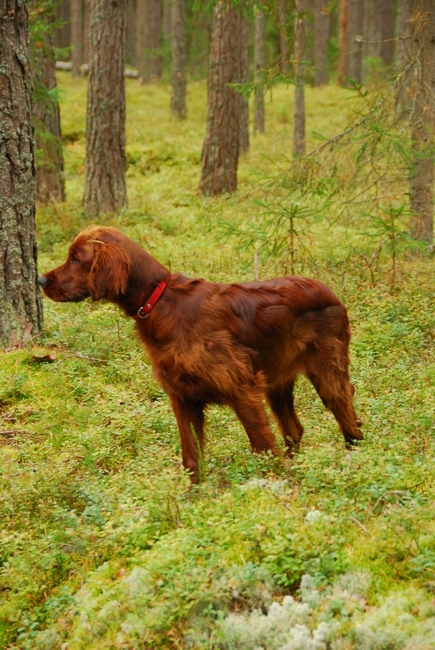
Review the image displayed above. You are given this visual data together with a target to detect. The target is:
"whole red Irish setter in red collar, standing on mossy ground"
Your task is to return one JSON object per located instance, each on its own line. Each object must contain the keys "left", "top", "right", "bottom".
{"left": 39, "top": 226, "right": 363, "bottom": 483}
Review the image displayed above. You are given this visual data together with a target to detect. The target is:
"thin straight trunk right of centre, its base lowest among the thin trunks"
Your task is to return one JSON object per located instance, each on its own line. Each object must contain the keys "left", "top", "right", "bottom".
{"left": 293, "top": 0, "right": 305, "bottom": 156}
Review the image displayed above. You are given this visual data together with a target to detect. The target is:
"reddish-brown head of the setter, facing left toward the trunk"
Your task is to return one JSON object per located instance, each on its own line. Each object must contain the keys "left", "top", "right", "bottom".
{"left": 38, "top": 226, "right": 131, "bottom": 302}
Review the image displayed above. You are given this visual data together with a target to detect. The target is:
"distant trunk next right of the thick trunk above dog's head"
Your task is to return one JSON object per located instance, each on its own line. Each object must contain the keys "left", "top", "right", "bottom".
{"left": 136, "top": 0, "right": 162, "bottom": 83}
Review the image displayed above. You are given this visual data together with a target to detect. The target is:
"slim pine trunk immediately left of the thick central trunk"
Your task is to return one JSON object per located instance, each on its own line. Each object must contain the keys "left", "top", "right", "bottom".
{"left": 171, "top": 0, "right": 186, "bottom": 120}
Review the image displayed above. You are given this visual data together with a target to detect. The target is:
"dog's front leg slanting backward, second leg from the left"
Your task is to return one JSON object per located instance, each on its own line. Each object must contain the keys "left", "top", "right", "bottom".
{"left": 228, "top": 386, "right": 278, "bottom": 454}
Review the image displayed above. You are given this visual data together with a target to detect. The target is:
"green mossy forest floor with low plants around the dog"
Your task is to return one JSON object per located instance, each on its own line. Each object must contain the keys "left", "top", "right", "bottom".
{"left": 0, "top": 73, "right": 435, "bottom": 650}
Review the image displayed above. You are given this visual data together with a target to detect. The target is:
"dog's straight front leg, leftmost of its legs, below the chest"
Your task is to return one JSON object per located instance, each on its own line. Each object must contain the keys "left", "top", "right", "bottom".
{"left": 171, "top": 397, "right": 204, "bottom": 483}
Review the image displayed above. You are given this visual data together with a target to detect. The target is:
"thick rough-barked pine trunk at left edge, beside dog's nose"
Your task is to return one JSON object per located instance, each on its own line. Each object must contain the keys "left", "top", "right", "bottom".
{"left": 0, "top": 0, "right": 42, "bottom": 348}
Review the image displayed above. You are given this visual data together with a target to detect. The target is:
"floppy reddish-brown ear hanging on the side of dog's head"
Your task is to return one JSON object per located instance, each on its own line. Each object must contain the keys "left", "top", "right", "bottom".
{"left": 88, "top": 241, "right": 130, "bottom": 300}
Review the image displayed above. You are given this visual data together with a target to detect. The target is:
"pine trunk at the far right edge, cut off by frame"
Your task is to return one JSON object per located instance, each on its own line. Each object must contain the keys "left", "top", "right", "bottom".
{"left": 410, "top": 0, "right": 435, "bottom": 244}
